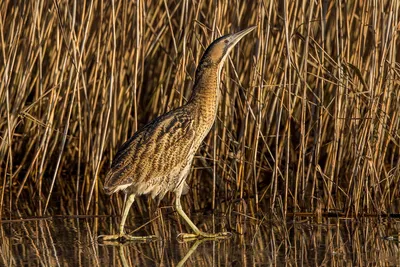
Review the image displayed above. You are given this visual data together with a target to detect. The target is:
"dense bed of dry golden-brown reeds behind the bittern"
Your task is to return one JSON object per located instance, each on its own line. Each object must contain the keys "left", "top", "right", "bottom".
{"left": 0, "top": 0, "right": 400, "bottom": 220}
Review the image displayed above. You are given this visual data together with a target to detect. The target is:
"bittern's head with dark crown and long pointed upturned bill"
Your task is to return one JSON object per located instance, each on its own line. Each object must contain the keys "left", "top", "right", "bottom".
{"left": 199, "top": 26, "right": 256, "bottom": 72}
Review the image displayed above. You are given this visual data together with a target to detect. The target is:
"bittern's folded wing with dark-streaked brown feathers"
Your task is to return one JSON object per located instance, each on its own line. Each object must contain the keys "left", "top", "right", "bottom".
{"left": 104, "top": 108, "right": 195, "bottom": 194}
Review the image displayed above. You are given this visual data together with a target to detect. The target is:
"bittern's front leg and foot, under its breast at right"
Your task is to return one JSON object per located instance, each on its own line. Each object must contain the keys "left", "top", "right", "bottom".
{"left": 175, "top": 194, "right": 231, "bottom": 241}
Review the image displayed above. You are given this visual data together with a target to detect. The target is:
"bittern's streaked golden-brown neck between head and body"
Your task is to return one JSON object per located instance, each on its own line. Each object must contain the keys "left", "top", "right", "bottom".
{"left": 188, "top": 65, "right": 221, "bottom": 138}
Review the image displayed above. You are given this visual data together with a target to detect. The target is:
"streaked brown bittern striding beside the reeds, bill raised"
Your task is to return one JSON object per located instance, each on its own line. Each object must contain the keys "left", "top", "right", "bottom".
{"left": 102, "top": 27, "right": 255, "bottom": 241}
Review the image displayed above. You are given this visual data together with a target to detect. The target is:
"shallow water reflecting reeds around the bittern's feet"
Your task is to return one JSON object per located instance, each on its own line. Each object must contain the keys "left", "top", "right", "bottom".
{"left": 0, "top": 213, "right": 400, "bottom": 266}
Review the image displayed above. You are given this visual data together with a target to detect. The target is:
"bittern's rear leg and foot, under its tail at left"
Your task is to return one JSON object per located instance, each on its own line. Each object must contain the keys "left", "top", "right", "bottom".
{"left": 99, "top": 194, "right": 157, "bottom": 243}
